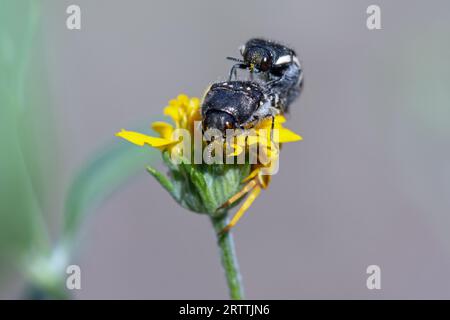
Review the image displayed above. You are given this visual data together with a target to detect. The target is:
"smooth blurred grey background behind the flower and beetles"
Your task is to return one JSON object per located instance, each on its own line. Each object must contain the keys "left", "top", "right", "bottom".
{"left": 5, "top": 0, "right": 450, "bottom": 299}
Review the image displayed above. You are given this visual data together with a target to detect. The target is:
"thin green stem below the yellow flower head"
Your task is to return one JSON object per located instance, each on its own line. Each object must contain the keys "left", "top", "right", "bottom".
{"left": 211, "top": 214, "right": 244, "bottom": 300}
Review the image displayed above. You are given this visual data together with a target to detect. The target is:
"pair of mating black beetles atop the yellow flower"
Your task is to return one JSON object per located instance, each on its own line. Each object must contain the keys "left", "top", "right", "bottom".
{"left": 202, "top": 39, "right": 303, "bottom": 134}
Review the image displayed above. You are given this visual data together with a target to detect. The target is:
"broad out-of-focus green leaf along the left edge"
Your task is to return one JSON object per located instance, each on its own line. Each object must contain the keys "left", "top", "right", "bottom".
{"left": 0, "top": 0, "right": 51, "bottom": 268}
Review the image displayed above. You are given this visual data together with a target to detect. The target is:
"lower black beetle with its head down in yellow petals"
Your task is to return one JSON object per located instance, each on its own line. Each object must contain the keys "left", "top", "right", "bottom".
{"left": 202, "top": 81, "right": 279, "bottom": 134}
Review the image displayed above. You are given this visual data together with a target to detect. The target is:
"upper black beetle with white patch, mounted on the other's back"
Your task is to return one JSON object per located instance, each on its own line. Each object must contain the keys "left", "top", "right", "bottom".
{"left": 228, "top": 39, "right": 303, "bottom": 112}
